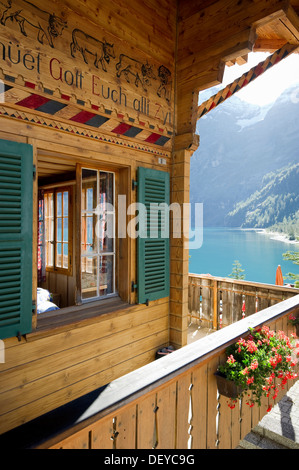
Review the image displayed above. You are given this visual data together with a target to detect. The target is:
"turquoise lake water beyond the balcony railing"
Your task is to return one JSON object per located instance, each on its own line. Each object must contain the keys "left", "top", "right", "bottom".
{"left": 189, "top": 227, "right": 299, "bottom": 284}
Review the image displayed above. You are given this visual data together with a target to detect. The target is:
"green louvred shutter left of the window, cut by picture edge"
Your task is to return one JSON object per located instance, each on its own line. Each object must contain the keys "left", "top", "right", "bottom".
{"left": 0, "top": 140, "right": 33, "bottom": 339}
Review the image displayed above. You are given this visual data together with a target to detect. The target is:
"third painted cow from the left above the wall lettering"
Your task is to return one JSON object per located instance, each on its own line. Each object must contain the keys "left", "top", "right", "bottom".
{"left": 116, "top": 54, "right": 156, "bottom": 91}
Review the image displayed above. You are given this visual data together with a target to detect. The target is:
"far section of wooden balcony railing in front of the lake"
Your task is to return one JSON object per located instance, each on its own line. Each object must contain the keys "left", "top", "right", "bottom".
{"left": 188, "top": 274, "right": 299, "bottom": 330}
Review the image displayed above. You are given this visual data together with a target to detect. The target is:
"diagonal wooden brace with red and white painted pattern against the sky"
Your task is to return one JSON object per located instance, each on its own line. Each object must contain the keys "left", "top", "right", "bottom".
{"left": 197, "top": 44, "right": 298, "bottom": 119}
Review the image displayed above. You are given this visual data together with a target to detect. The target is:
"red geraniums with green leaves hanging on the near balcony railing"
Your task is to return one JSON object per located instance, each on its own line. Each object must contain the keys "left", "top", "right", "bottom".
{"left": 216, "top": 326, "right": 299, "bottom": 411}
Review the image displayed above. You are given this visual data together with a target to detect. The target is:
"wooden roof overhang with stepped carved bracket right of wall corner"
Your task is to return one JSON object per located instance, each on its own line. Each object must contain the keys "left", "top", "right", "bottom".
{"left": 177, "top": 0, "right": 299, "bottom": 139}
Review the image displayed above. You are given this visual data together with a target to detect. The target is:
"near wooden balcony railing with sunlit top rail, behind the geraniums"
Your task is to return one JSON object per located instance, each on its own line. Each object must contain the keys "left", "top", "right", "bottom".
{"left": 35, "top": 295, "right": 299, "bottom": 449}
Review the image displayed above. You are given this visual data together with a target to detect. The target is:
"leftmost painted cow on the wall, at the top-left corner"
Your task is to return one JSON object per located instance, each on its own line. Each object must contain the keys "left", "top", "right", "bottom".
{"left": 0, "top": 0, "right": 67, "bottom": 47}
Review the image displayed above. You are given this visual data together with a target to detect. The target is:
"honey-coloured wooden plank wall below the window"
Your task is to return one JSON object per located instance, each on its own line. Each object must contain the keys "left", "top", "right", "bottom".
{"left": 0, "top": 299, "right": 168, "bottom": 433}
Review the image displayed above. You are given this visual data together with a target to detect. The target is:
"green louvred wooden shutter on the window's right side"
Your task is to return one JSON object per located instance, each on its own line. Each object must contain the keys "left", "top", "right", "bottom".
{"left": 137, "top": 167, "right": 169, "bottom": 303}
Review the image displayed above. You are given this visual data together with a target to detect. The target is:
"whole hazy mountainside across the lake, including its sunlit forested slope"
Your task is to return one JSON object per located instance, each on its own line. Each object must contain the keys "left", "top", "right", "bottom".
{"left": 190, "top": 87, "right": 299, "bottom": 233}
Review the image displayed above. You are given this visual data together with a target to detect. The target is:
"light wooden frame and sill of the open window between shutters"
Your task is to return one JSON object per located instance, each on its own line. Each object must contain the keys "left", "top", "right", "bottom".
{"left": 33, "top": 158, "right": 129, "bottom": 324}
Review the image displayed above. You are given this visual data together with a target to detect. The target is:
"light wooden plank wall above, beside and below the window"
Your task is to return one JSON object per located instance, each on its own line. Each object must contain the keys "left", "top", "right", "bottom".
{"left": 0, "top": 86, "right": 170, "bottom": 436}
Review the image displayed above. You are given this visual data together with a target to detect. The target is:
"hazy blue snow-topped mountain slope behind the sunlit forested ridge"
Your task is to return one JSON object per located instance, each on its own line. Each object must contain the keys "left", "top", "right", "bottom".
{"left": 190, "top": 87, "right": 299, "bottom": 226}
